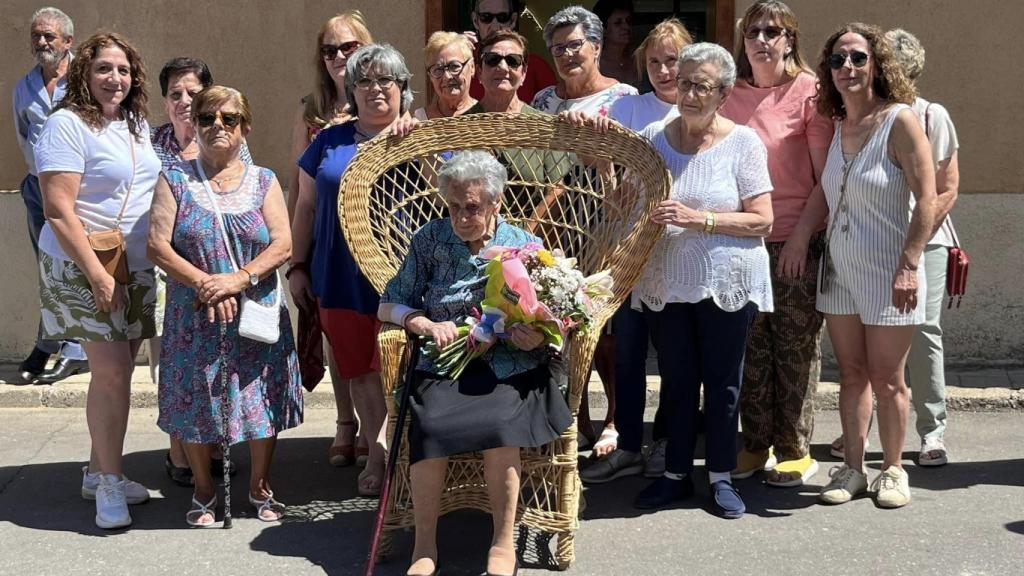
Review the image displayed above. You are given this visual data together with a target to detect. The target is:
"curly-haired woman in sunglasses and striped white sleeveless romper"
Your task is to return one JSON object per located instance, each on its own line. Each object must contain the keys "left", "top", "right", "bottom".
{"left": 817, "top": 23, "right": 936, "bottom": 507}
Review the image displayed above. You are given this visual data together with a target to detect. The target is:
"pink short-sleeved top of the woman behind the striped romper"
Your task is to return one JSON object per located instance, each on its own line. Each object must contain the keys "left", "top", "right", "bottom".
{"left": 722, "top": 74, "right": 834, "bottom": 242}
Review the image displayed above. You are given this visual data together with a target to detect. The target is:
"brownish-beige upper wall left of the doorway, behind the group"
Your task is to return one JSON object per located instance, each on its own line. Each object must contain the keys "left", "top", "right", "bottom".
{"left": 0, "top": 0, "right": 424, "bottom": 190}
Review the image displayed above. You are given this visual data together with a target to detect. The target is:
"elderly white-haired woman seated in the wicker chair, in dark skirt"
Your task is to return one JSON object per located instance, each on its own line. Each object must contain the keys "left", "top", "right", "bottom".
{"left": 378, "top": 151, "right": 571, "bottom": 574}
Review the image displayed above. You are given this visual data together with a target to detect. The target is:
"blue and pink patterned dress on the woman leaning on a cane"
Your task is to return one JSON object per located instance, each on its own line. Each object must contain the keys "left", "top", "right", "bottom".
{"left": 157, "top": 163, "right": 302, "bottom": 444}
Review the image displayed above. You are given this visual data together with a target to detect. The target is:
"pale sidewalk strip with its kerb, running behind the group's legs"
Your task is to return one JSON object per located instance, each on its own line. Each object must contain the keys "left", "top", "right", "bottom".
{"left": 0, "top": 364, "right": 1024, "bottom": 412}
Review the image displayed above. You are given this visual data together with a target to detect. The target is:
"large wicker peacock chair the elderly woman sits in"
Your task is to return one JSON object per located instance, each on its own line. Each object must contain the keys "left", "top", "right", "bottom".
{"left": 338, "top": 114, "right": 671, "bottom": 569}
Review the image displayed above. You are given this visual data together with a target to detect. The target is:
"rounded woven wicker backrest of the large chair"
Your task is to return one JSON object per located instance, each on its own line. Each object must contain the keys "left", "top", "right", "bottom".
{"left": 338, "top": 114, "right": 671, "bottom": 322}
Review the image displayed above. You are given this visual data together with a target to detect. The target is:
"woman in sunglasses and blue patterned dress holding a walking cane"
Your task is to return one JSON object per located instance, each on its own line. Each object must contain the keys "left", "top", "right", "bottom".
{"left": 148, "top": 86, "right": 302, "bottom": 527}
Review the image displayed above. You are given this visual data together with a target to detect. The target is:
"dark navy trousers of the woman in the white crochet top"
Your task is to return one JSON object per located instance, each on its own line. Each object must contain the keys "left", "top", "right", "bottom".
{"left": 644, "top": 298, "right": 758, "bottom": 474}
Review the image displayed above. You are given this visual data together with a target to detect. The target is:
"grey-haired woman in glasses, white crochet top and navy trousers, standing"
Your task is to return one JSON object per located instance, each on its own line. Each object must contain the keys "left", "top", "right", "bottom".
{"left": 633, "top": 43, "right": 772, "bottom": 518}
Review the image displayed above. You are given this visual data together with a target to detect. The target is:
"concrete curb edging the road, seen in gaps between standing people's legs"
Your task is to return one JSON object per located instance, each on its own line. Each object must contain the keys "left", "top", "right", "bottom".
{"left": 0, "top": 370, "right": 1024, "bottom": 413}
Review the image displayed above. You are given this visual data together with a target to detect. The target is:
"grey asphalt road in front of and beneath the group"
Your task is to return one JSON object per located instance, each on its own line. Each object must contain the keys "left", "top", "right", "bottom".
{"left": 0, "top": 409, "right": 1024, "bottom": 576}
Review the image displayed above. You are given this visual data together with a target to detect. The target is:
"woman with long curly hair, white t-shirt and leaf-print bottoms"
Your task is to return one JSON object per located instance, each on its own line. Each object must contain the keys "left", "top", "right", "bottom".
{"left": 35, "top": 33, "right": 160, "bottom": 528}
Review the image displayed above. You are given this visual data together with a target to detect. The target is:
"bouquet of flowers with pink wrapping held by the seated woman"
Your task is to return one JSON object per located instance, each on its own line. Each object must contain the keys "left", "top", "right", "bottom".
{"left": 424, "top": 243, "right": 612, "bottom": 379}
